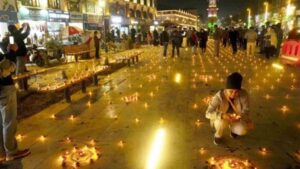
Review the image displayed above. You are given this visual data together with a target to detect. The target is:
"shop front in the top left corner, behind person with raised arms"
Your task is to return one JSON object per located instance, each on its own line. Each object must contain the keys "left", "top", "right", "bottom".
{"left": 0, "top": 0, "right": 18, "bottom": 39}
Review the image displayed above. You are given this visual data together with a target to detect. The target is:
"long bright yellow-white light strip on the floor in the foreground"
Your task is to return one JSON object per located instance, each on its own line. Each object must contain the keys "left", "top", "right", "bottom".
{"left": 146, "top": 129, "right": 166, "bottom": 169}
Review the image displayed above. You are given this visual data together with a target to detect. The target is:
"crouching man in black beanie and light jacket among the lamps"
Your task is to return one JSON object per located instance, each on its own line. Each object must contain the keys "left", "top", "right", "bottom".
{"left": 206, "top": 72, "right": 251, "bottom": 145}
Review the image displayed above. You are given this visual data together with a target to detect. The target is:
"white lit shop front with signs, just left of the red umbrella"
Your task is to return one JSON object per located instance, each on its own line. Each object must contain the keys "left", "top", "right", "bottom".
{"left": 47, "top": 10, "right": 70, "bottom": 36}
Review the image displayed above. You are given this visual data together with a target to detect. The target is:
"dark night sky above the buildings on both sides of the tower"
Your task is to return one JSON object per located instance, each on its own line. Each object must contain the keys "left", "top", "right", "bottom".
{"left": 157, "top": 0, "right": 257, "bottom": 20}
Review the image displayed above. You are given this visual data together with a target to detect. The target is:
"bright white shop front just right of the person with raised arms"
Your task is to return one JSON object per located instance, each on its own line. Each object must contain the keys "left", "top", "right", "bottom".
{"left": 18, "top": 7, "right": 48, "bottom": 44}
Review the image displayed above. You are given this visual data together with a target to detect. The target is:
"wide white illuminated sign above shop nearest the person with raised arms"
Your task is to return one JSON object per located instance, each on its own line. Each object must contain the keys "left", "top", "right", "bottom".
{"left": 19, "top": 8, "right": 48, "bottom": 21}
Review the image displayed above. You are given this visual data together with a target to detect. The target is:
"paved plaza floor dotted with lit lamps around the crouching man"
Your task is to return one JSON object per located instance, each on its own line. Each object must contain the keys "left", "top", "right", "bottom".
{"left": 1, "top": 42, "right": 300, "bottom": 169}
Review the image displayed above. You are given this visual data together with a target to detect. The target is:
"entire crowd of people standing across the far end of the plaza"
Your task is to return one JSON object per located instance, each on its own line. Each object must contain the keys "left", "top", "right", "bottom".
{"left": 138, "top": 23, "right": 284, "bottom": 59}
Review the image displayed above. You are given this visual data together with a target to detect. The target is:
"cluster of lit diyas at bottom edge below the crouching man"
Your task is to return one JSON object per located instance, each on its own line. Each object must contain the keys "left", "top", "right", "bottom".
{"left": 207, "top": 156, "right": 256, "bottom": 169}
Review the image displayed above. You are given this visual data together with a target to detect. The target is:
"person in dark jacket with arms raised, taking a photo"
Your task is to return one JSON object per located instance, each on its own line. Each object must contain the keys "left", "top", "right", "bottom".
{"left": 8, "top": 23, "right": 30, "bottom": 75}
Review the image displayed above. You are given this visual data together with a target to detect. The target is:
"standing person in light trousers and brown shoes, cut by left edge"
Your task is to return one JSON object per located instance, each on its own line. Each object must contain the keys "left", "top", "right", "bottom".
{"left": 0, "top": 44, "right": 30, "bottom": 163}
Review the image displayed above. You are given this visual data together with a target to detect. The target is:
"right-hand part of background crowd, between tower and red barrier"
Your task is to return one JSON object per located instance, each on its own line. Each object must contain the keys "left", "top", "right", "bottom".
{"left": 213, "top": 23, "right": 284, "bottom": 59}
